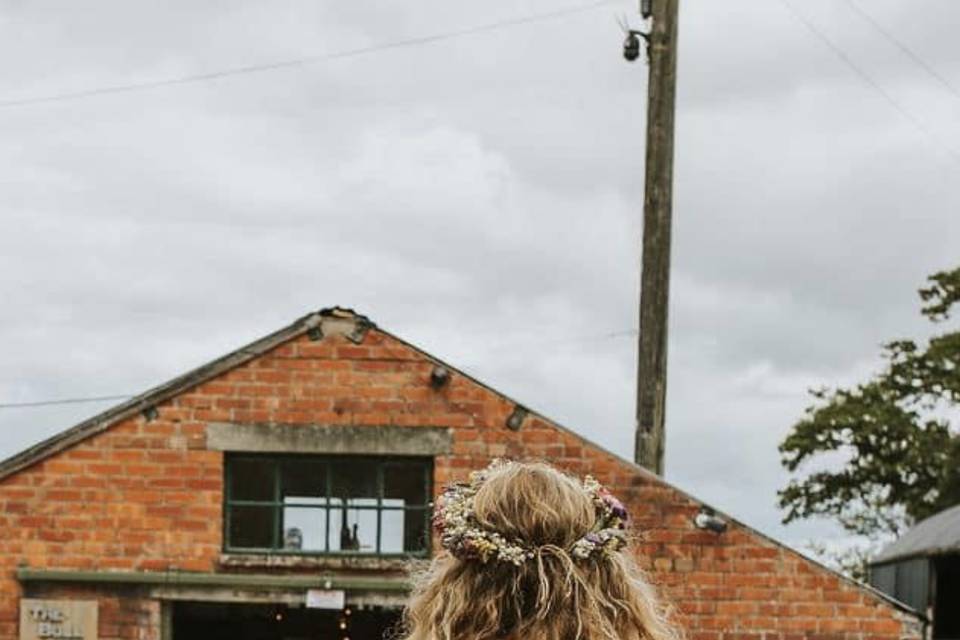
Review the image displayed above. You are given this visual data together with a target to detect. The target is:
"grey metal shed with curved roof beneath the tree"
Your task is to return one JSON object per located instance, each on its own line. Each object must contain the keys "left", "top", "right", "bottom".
{"left": 870, "top": 505, "right": 960, "bottom": 640}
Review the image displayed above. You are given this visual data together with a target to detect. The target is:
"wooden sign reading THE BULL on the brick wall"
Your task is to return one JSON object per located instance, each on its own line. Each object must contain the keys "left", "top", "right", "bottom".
{"left": 20, "top": 598, "right": 97, "bottom": 640}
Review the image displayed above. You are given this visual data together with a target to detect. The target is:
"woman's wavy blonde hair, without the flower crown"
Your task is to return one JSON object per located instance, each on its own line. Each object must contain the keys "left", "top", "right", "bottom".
{"left": 403, "top": 462, "right": 680, "bottom": 640}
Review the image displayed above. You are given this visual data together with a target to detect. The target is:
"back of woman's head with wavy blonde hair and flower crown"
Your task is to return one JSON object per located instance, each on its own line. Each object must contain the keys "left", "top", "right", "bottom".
{"left": 404, "top": 462, "right": 677, "bottom": 640}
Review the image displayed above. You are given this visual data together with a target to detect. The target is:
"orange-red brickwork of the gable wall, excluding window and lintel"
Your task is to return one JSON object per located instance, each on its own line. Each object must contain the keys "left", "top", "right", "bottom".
{"left": 0, "top": 330, "right": 917, "bottom": 640}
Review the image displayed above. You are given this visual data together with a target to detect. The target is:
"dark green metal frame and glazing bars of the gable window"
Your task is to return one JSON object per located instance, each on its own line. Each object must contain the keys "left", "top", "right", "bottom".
{"left": 222, "top": 452, "right": 434, "bottom": 558}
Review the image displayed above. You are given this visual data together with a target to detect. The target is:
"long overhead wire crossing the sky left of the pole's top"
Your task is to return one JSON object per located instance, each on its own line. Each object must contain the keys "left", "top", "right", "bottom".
{"left": 0, "top": 0, "right": 619, "bottom": 108}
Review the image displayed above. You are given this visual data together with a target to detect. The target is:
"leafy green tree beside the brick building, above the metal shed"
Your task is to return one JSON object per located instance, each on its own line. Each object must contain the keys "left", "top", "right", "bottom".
{"left": 778, "top": 268, "right": 960, "bottom": 538}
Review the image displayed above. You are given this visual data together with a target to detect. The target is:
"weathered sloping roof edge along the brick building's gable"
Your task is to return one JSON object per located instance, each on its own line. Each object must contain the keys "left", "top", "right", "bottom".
{"left": 0, "top": 307, "right": 923, "bottom": 619}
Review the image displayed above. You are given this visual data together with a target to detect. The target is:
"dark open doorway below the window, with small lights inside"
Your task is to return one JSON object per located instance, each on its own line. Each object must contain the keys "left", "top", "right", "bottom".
{"left": 172, "top": 602, "right": 400, "bottom": 640}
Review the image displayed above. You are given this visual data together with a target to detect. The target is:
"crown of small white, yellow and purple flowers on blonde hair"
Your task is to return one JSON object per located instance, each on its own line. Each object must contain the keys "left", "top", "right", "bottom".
{"left": 433, "top": 460, "right": 628, "bottom": 566}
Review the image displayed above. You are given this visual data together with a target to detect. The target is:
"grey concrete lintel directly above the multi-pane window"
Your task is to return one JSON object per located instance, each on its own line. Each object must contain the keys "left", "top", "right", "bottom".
{"left": 207, "top": 422, "right": 453, "bottom": 456}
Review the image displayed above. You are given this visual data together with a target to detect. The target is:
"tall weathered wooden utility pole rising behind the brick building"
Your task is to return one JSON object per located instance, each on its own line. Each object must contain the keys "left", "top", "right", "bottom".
{"left": 634, "top": 0, "right": 679, "bottom": 475}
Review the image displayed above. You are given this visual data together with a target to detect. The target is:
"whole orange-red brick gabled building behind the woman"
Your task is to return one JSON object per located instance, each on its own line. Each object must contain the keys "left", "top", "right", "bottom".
{"left": 0, "top": 309, "right": 922, "bottom": 640}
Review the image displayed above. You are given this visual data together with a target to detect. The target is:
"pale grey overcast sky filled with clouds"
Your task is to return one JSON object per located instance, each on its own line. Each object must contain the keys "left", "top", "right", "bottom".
{"left": 0, "top": 0, "right": 960, "bottom": 544}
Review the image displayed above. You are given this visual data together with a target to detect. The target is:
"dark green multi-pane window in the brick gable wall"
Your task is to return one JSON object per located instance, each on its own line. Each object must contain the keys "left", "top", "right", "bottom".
{"left": 224, "top": 454, "right": 433, "bottom": 555}
